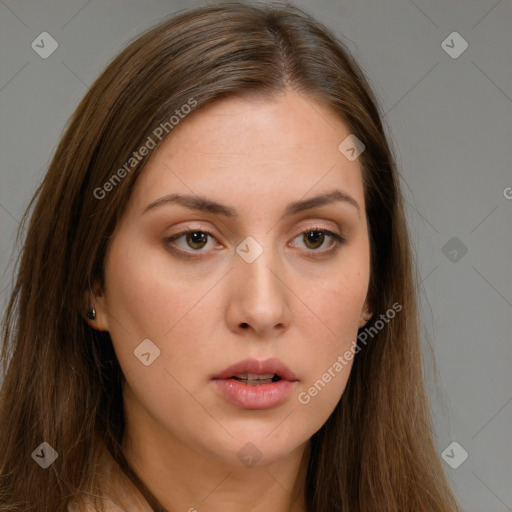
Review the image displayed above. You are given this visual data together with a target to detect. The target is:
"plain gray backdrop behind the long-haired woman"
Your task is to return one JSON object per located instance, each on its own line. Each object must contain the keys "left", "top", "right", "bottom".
{"left": 0, "top": 0, "right": 512, "bottom": 512}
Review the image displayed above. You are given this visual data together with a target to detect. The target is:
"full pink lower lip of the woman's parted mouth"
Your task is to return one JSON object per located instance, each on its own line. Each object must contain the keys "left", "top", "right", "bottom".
{"left": 212, "top": 379, "right": 296, "bottom": 409}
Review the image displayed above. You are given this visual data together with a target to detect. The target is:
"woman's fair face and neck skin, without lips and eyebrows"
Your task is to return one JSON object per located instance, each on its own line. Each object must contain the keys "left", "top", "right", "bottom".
{"left": 89, "top": 90, "right": 371, "bottom": 512}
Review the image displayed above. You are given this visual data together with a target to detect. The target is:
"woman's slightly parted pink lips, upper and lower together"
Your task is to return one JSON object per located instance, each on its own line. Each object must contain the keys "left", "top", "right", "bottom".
{"left": 210, "top": 359, "right": 298, "bottom": 409}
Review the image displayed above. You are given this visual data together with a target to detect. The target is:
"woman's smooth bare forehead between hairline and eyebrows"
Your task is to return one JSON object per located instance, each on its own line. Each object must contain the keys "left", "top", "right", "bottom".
{"left": 130, "top": 90, "right": 364, "bottom": 213}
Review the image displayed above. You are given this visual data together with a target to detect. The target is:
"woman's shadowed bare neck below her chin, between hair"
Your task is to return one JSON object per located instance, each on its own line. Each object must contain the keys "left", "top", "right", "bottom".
{"left": 123, "top": 416, "right": 310, "bottom": 512}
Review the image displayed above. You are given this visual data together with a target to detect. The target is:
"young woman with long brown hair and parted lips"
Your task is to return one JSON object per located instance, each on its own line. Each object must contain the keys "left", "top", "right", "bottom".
{"left": 0, "top": 3, "right": 459, "bottom": 512}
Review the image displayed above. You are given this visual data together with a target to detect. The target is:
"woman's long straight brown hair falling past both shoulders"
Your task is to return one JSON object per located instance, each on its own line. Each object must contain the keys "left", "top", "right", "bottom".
{"left": 0, "top": 2, "right": 460, "bottom": 512}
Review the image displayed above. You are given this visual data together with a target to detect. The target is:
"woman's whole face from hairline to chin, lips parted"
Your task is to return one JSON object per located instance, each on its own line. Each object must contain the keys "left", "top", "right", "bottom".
{"left": 91, "top": 87, "right": 370, "bottom": 465}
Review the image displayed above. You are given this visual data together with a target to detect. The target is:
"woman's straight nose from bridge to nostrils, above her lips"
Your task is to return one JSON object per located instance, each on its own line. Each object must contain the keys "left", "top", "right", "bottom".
{"left": 227, "top": 240, "right": 291, "bottom": 339}
